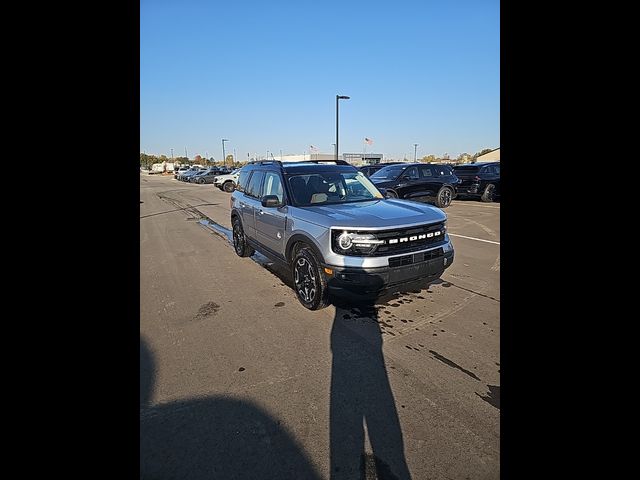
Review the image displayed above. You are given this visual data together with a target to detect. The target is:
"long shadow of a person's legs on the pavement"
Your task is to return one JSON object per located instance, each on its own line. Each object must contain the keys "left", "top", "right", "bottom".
{"left": 330, "top": 299, "right": 411, "bottom": 480}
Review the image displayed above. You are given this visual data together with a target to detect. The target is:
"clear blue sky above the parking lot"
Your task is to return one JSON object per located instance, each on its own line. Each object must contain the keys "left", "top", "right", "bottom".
{"left": 140, "top": 0, "right": 500, "bottom": 160}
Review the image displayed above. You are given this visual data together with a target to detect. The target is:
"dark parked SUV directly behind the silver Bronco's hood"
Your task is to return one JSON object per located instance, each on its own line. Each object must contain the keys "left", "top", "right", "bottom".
{"left": 371, "top": 163, "right": 459, "bottom": 208}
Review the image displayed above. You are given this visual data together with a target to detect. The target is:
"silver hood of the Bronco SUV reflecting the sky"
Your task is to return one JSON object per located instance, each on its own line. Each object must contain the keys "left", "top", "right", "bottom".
{"left": 292, "top": 199, "right": 447, "bottom": 228}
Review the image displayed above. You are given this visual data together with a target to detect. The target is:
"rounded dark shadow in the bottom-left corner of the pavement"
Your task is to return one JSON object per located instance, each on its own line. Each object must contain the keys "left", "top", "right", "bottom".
{"left": 140, "top": 339, "right": 320, "bottom": 480}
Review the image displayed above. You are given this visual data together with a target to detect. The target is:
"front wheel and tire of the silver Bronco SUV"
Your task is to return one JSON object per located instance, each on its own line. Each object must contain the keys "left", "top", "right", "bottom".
{"left": 291, "top": 247, "right": 329, "bottom": 310}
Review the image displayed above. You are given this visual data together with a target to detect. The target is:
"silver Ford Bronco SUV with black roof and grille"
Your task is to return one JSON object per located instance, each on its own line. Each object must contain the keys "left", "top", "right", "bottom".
{"left": 230, "top": 160, "right": 454, "bottom": 310}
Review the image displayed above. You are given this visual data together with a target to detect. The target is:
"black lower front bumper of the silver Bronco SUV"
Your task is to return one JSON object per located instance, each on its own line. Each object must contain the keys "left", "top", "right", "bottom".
{"left": 327, "top": 248, "right": 454, "bottom": 299}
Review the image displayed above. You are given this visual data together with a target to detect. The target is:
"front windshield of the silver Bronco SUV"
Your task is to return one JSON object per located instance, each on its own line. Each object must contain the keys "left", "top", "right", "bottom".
{"left": 289, "top": 172, "right": 384, "bottom": 207}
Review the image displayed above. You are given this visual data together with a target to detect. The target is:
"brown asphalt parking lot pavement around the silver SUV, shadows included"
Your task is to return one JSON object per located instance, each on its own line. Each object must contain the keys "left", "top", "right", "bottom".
{"left": 140, "top": 174, "right": 500, "bottom": 479}
